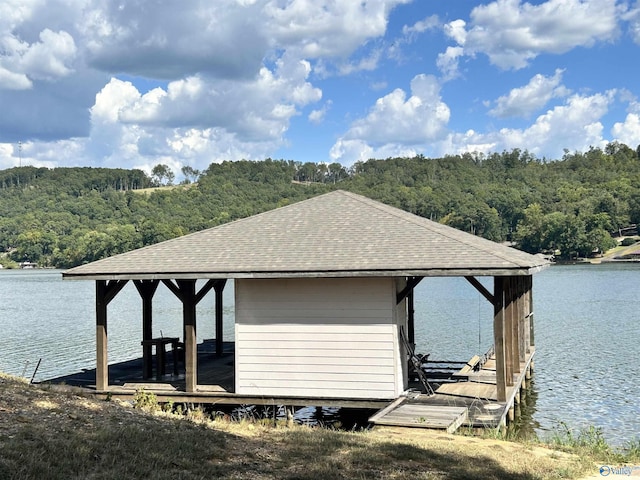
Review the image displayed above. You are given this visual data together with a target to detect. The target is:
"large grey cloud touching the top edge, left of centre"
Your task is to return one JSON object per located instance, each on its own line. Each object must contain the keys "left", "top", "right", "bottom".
{"left": 78, "top": 0, "right": 270, "bottom": 80}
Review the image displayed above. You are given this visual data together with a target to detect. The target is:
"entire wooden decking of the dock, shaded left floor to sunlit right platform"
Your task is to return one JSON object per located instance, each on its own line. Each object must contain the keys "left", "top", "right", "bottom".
{"left": 48, "top": 341, "right": 535, "bottom": 432}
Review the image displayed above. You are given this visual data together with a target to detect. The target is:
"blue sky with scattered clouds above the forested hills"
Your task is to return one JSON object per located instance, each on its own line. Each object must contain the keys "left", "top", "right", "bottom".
{"left": 0, "top": 0, "right": 640, "bottom": 175}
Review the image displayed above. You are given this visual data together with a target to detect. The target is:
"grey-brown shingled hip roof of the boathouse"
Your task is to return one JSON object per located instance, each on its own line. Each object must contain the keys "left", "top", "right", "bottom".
{"left": 63, "top": 190, "right": 548, "bottom": 279}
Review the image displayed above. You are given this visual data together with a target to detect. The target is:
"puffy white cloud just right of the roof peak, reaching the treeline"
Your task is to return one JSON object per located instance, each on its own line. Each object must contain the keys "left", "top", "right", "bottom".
{"left": 331, "top": 74, "right": 450, "bottom": 163}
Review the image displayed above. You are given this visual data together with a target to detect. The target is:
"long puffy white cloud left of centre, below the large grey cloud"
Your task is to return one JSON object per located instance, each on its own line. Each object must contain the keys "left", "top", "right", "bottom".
{"left": 112, "top": 58, "right": 322, "bottom": 142}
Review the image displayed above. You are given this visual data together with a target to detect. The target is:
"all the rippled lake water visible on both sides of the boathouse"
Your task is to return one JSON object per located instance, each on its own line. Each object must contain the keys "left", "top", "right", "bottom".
{"left": 0, "top": 264, "right": 640, "bottom": 444}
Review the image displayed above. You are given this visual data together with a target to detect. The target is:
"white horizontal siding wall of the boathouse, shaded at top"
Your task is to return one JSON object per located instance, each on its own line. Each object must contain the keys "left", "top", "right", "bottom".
{"left": 235, "top": 278, "right": 403, "bottom": 399}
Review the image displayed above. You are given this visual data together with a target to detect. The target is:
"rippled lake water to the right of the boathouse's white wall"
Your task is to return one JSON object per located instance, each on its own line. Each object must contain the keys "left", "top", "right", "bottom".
{"left": 416, "top": 264, "right": 640, "bottom": 444}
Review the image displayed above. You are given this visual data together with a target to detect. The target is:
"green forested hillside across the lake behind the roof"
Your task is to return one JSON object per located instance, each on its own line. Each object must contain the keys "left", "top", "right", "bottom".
{"left": 0, "top": 143, "right": 640, "bottom": 268}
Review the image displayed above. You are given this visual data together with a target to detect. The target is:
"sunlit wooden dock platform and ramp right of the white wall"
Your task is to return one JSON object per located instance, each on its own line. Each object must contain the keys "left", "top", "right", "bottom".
{"left": 369, "top": 349, "right": 535, "bottom": 432}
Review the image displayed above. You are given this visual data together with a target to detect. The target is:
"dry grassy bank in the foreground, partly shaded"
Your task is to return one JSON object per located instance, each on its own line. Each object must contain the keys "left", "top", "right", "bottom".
{"left": 0, "top": 375, "right": 636, "bottom": 480}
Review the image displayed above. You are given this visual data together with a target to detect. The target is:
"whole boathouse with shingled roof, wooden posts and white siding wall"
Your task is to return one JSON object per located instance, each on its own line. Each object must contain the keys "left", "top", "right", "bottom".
{"left": 63, "top": 190, "right": 548, "bottom": 428}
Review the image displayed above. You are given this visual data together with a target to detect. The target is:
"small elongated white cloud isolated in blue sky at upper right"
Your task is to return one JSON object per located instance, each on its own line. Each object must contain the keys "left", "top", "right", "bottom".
{"left": 489, "top": 69, "right": 570, "bottom": 118}
